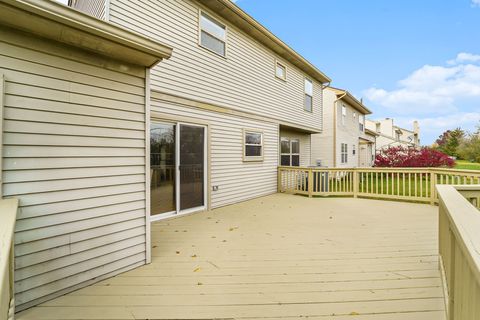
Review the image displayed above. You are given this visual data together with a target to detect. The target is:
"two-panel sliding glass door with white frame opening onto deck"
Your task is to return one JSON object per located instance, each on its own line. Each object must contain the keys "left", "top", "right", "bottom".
{"left": 150, "top": 122, "right": 207, "bottom": 217}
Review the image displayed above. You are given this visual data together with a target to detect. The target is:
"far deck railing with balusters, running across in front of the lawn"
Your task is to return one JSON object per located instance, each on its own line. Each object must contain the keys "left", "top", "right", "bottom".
{"left": 278, "top": 167, "right": 480, "bottom": 204}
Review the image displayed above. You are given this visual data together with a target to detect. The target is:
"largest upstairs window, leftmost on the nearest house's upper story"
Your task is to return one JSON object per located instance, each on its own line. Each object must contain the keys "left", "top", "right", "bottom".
{"left": 200, "top": 12, "right": 227, "bottom": 57}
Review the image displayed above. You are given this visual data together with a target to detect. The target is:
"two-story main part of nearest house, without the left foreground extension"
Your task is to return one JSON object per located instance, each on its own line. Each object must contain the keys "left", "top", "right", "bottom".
{"left": 71, "top": 0, "right": 330, "bottom": 215}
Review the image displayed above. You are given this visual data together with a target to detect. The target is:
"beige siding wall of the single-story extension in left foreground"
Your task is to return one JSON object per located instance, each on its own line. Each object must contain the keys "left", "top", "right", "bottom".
{"left": 0, "top": 28, "right": 146, "bottom": 309}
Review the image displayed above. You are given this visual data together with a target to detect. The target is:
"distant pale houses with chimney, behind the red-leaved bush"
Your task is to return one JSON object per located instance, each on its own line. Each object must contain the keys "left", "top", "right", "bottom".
{"left": 365, "top": 118, "right": 420, "bottom": 151}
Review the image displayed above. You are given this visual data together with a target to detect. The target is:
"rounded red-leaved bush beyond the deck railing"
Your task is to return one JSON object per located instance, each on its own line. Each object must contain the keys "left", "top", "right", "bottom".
{"left": 374, "top": 147, "right": 455, "bottom": 168}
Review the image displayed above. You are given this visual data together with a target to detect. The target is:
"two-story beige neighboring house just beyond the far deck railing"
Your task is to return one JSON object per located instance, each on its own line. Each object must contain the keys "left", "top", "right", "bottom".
{"left": 312, "top": 87, "right": 375, "bottom": 168}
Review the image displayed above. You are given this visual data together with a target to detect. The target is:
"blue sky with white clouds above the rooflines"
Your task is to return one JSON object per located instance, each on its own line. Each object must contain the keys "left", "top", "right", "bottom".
{"left": 235, "top": 0, "right": 480, "bottom": 145}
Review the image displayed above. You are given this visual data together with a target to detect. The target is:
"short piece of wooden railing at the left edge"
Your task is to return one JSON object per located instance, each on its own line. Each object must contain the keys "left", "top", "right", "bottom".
{"left": 0, "top": 199, "right": 18, "bottom": 320}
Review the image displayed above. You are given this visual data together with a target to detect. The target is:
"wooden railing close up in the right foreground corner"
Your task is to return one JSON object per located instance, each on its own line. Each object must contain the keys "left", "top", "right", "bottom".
{"left": 437, "top": 185, "right": 480, "bottom": 320}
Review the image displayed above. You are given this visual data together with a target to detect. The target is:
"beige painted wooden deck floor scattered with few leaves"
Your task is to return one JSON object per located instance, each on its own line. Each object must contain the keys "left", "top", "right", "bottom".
{"left": 17, "top": 194, "right": 444, "bottom": 320}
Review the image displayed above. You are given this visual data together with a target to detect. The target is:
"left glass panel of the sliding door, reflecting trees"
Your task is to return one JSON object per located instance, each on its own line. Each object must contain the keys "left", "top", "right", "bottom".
{"left": 150, "top": 122, "right": 177, "bottom": 215}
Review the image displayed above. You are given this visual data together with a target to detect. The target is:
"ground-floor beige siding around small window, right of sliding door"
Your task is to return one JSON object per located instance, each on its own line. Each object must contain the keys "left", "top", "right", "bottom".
{"left": 151, "top": 99, "right": 279, "bottom": 208}
